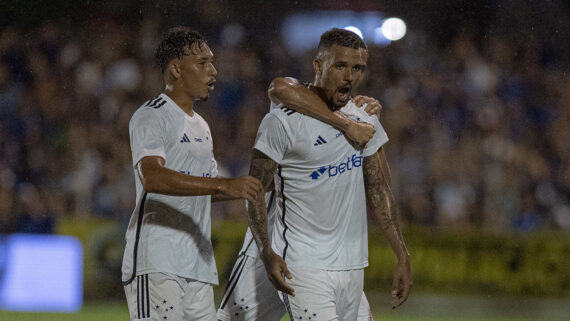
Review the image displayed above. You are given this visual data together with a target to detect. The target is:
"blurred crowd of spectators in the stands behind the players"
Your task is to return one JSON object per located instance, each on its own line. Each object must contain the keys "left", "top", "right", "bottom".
{"left": 0, "top": 3, "right": 570, "bottom": 233}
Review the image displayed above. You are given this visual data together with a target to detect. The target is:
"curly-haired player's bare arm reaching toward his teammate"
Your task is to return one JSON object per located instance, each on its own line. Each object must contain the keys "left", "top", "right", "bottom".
{"left": 137, "top": 156, "right": 263, "bottom": 200}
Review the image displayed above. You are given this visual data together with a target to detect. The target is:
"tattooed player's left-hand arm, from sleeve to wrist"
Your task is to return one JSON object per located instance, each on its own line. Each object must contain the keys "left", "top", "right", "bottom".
{"left": 247, "top": 149, "right": 277, "bottom": 251}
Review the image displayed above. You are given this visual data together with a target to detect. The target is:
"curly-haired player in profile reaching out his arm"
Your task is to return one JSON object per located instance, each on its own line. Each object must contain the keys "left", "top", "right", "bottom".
{"left": 122, "top": 27, "right": 263, "bottom": 321}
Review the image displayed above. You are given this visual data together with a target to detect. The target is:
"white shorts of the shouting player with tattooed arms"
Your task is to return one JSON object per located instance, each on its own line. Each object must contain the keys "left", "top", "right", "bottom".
{"left": 282, "top": 267, "right": 364, "bottom": 321}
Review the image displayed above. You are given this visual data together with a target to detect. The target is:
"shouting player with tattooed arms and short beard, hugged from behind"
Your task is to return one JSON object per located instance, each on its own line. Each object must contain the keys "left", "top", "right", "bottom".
{"left": 248, "top": 29, "right": 412, "bottom": 321}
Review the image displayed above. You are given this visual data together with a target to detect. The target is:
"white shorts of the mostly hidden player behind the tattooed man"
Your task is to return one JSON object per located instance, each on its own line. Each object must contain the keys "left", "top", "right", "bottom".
{"left": 217, "top": 255, "right": 373, "bottom": 321}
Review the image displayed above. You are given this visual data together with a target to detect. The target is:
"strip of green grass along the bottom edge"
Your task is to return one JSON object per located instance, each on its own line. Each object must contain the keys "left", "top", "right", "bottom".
{"left": 0, "top": 293, "right": 570, "bottom": 321}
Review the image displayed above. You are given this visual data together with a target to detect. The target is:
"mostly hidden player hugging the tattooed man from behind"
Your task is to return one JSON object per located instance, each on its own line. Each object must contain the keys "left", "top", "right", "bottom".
{"left": 217, "top": 89, "right": 382, "bottom": 321}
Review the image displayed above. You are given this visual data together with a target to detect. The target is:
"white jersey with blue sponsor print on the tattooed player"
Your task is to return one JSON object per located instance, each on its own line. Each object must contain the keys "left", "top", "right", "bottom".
{"left": 254, "top": 102, "right": 388, "bottom": 270}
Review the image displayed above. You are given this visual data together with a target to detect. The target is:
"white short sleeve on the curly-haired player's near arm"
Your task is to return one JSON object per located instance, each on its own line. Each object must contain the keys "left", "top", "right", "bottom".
{"left": 129, "top": 107, "right": 166, "bottom": 166}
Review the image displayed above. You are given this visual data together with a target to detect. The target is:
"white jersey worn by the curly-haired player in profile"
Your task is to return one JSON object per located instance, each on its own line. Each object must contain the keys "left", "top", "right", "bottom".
{"left": 122, "top": 94, "right": 218, "bottom": 285}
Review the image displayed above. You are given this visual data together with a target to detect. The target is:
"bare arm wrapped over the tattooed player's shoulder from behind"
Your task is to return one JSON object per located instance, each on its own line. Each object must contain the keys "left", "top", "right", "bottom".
{"left": 267, "top": 77, "right": 374, "bottom": 146}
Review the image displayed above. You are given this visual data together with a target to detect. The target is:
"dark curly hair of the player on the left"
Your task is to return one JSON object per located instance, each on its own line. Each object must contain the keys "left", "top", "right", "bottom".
{"left": 154, "top": 27, "right": 208, "bottom": 72}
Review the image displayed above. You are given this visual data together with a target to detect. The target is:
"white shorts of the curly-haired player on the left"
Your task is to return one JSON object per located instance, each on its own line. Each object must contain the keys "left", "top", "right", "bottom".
{"left": 125, "top": 273, "right": 216, "bottom": 321}
